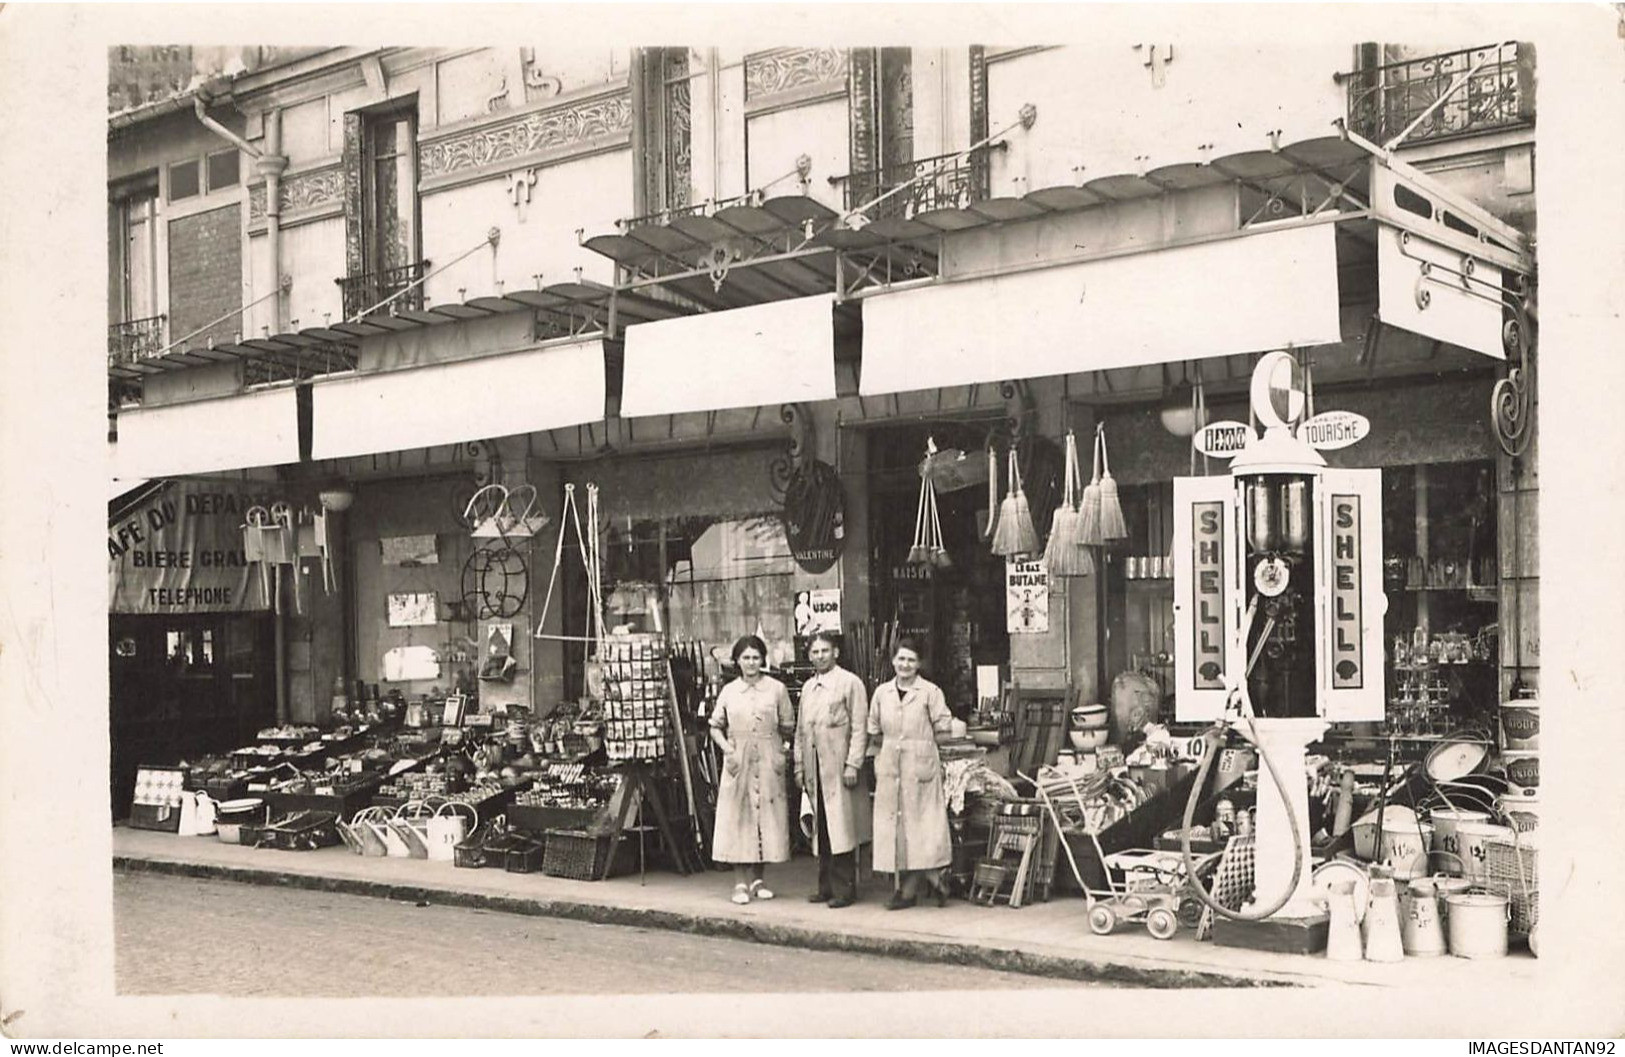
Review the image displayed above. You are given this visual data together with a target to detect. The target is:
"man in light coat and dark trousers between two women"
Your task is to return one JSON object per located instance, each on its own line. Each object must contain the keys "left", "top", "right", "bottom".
{"left": 795, "top": 631, "right": 871, "bottom": 909}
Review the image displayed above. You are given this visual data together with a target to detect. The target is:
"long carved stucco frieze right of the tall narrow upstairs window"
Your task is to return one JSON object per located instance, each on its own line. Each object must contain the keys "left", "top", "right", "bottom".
{"left": 418, "top": 93, "right": 632, "bottom": 181}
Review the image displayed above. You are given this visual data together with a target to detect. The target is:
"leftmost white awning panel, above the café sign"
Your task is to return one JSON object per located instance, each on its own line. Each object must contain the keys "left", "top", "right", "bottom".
{"left": 114, "top": 387, "right": 299, "bottom": 480}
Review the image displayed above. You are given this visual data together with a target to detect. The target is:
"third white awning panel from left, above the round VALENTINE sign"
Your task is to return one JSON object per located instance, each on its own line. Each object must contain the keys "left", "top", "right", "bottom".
{"left": 621, "top": 294, "right": 835, "bottom": 418}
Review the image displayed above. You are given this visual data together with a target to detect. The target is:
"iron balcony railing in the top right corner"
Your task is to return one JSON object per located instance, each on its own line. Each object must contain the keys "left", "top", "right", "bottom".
{"left": 1339, "top": 42, "right": 1534, "bottom": 145}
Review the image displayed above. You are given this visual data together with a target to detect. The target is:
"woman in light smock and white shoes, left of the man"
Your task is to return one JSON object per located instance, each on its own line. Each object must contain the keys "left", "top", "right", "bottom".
{"left": 710, "top": 634, "right": 796, "bottom": 904}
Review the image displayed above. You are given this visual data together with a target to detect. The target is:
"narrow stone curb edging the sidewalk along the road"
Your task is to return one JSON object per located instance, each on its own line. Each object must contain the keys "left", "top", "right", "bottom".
{"left": 112, "top": 855, "right": 1308, "bottom": 989}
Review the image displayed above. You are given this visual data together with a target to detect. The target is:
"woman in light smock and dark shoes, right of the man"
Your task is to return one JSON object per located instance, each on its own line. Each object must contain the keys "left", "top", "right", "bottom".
{"left": 868, "top": 637, "right": 954, "bottom": 911}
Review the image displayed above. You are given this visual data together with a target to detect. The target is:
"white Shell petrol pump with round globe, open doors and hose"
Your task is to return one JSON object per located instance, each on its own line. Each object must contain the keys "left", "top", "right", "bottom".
{"left": 1173, "top": 351, "right": 1386, "bottom": 920}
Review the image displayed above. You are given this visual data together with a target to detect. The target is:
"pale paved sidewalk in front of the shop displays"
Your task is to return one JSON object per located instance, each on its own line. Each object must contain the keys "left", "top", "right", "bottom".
{"left": 112, "top": 826, "right": 1537, "bottom": 994}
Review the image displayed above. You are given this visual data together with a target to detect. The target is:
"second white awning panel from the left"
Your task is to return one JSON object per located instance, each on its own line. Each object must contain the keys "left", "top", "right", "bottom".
{"left": 310, "top": 337, "right": 605, "bottom": 459}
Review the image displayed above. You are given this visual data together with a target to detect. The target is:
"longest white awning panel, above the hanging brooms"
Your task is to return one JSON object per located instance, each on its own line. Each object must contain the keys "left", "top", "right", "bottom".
{"left": 858, "top": 223, "right": 1341, "bottom": 395}
